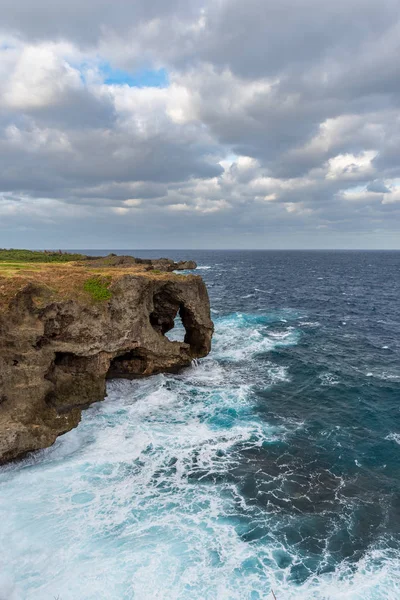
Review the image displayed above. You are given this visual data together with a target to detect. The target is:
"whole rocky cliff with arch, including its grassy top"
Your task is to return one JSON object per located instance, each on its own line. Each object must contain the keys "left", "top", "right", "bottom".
{"left": 0, "top": 251, "right": 213, "bottom": 462}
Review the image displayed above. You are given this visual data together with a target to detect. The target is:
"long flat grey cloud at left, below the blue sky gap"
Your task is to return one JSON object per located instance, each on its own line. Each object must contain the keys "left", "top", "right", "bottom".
{"left": 0, "top": 121, "right": 222, "bottom": 197}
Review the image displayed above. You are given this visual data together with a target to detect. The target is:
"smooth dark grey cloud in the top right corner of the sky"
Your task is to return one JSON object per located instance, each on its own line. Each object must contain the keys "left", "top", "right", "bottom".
{"left": 198, "top": 0, "right": 399, "bottom": 78}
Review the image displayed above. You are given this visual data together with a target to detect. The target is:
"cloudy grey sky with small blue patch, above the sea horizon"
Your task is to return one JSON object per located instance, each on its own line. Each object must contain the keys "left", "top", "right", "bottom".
{"left": 0, "top": 0, "right": 400, "bottom": 249}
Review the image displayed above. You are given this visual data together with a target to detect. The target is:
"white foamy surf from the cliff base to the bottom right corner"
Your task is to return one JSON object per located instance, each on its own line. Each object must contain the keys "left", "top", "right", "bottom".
{"left": 0, "top": 315, "right": 399, "bottom": 600}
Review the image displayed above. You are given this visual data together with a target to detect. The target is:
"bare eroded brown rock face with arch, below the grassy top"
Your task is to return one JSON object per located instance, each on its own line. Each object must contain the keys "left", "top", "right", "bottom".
{"left": 0, "top": 274, "right": 213, "bottom": 462}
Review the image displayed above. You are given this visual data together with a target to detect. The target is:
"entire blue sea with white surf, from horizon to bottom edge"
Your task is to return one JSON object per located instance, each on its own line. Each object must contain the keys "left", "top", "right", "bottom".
{"left": 0, "top": 250, "right": 400, "bottom": 600}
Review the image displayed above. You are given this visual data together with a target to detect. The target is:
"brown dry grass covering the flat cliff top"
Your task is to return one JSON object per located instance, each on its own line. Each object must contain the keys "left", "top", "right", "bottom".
{"left": 0, "top": 262, "right": 186, "bottom": 310}
